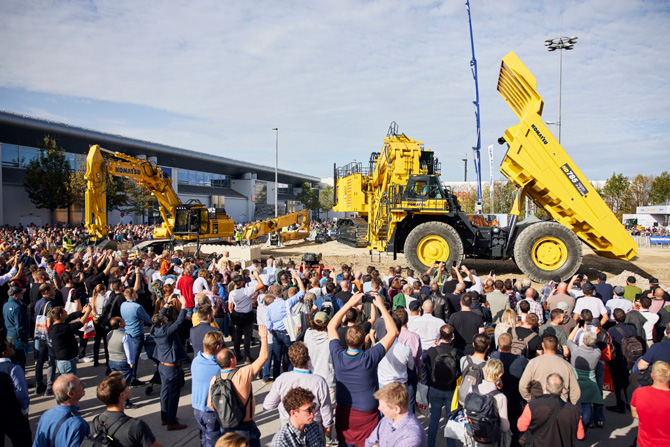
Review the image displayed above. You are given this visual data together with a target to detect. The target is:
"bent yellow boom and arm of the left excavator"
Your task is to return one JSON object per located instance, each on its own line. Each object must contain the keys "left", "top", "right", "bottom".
{"left": 84, "top": 144, "right": 181, "bottom": 241}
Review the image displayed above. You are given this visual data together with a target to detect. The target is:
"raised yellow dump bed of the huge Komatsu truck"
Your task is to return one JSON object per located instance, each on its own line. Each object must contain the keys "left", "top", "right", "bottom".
{"left": 498, "top": 52, "right": 638, "bottom": 261}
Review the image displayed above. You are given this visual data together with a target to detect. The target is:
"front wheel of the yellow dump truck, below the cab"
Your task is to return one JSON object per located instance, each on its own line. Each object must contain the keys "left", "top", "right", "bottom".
{"left": 404, "top": 222, "right": 463, "bottom": 274}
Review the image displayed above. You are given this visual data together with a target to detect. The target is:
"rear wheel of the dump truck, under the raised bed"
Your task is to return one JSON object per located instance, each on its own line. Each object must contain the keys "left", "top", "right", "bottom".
{"left": 514, "top": 222, "right": 582, "bottom": 284}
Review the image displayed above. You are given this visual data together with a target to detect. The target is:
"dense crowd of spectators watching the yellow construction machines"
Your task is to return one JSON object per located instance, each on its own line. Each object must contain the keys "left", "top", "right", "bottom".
{"left": 0, "top": 227, "right": 670, "bottom": 447}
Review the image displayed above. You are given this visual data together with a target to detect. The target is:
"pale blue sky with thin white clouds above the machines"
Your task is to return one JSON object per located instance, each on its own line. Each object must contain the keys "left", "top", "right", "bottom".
{"left": 0, "top": 0, "right": 670, "bottom": 181}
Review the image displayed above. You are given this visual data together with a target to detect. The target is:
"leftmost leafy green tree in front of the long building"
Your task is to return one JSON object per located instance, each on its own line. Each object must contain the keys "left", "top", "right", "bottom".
{"left": 24, "top": 135, "right": 77, "bottom": 224}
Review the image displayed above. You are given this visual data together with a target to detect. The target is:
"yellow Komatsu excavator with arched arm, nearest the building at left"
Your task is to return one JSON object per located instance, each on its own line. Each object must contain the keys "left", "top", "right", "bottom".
{"left": 84, "top": 145, "right": 235, "bottom": 252}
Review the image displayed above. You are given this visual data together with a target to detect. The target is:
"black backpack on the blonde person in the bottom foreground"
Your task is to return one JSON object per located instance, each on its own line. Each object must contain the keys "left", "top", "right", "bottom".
{"left": 464, "top": 385, "right": 500, "bottom": 444}
